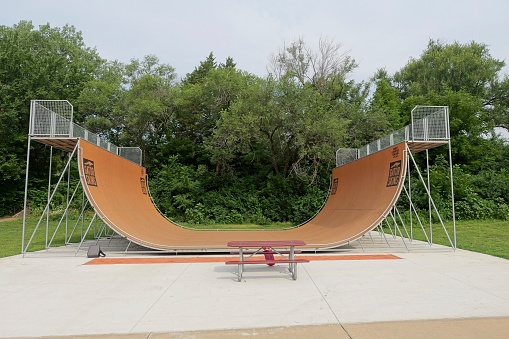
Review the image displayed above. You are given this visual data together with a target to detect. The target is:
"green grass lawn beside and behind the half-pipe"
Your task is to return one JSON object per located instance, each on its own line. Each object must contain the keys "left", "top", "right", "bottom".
{"left": 0, "top": 215, "right": 509, "bottom": 259}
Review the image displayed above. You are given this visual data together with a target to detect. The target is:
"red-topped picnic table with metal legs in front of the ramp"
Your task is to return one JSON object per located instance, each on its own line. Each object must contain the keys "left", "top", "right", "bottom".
{"left": 225, "top": 240, "right": 309, "bottom": 281}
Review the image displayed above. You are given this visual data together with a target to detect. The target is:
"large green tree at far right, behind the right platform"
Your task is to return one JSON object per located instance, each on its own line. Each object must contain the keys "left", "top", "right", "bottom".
{"left": 393, "top": 40, "right": 509, "bottom": 219}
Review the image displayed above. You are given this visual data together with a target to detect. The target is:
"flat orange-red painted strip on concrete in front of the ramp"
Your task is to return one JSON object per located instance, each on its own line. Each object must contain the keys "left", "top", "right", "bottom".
{"left": 85, "top": 254, "right": 401, "bottom": 265}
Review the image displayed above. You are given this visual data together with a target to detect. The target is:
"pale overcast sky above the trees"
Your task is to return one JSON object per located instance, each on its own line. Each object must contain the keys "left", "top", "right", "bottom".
{"left": 0, "top": 0, "right": 509, "bottom": 81}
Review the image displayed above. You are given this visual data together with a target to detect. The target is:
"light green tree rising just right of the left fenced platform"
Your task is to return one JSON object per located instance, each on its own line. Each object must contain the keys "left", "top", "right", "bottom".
{"left": 77, "top": 55, "right": 177, "bottom": 165}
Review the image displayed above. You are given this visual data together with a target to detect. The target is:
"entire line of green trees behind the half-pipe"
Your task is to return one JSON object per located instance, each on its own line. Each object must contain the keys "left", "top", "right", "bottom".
{"left": 0, "top": 21, "right": 509, "bottom": 224}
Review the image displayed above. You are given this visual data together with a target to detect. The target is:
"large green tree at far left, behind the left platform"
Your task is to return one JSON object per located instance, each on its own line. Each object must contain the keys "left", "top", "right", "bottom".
{"left": 0, "top": 21, "right": 103, "bottom": 215}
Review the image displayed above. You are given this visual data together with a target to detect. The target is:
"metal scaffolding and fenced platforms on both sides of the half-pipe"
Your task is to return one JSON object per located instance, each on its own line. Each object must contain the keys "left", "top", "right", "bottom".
{"left": 21, "top": 100, "right": 457, "bottom": 256}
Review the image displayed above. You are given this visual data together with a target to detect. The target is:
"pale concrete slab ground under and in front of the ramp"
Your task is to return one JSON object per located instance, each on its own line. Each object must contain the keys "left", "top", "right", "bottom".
{"left": 0, "top": 240, "right": 509, "bottom": 339}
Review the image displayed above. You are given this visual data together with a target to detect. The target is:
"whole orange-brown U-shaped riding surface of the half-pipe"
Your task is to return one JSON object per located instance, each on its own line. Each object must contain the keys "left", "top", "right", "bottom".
{"left": 78, "top": 139, "right": 406, "bottom": 251}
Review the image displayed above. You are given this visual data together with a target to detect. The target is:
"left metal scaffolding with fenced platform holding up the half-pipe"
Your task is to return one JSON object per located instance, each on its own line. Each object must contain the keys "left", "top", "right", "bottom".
{"left": 21, "top": 100, "right": 142, "bottom": 256}
